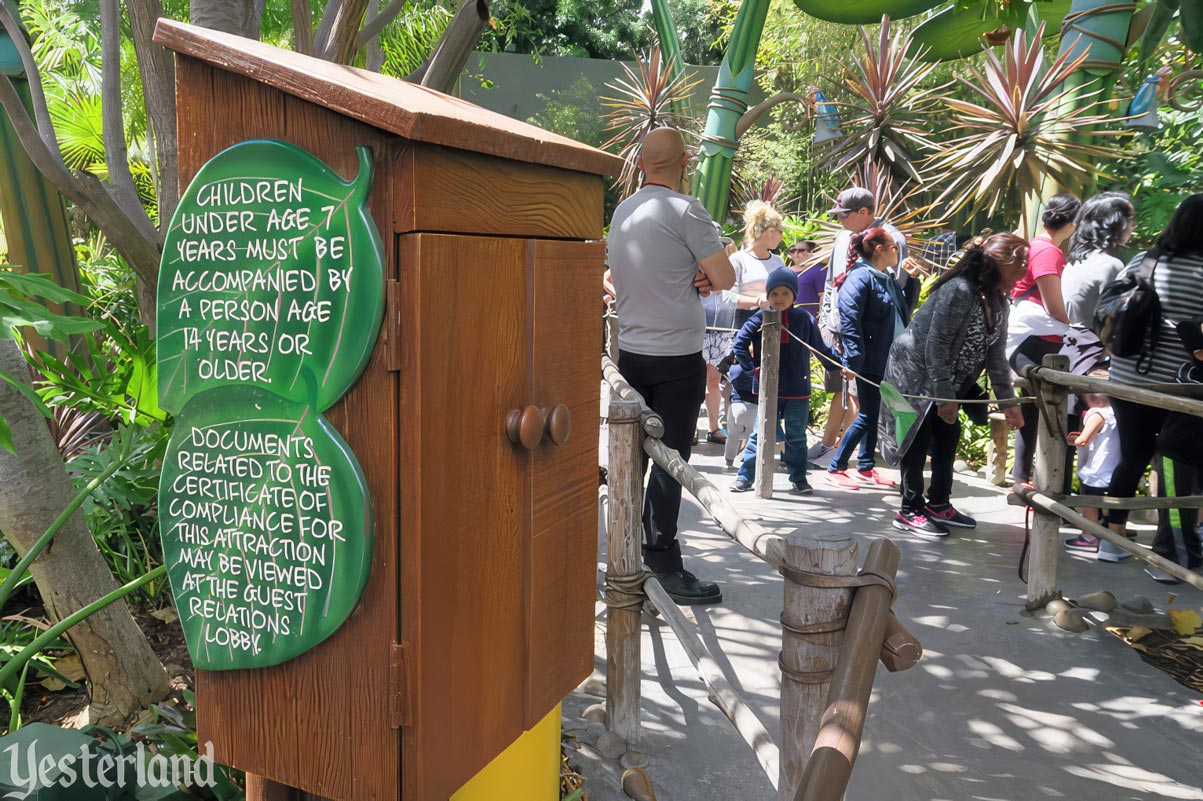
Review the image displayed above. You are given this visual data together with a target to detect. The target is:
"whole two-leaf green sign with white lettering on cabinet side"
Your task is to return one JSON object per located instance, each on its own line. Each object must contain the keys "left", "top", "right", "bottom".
{"left": 156, "top": 141, "right": 384, "bottom": 670}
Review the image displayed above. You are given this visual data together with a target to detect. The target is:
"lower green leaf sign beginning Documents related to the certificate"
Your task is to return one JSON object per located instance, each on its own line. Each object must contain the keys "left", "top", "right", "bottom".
{"left": 159, "top": 386, "right": 372, "bottom": 670}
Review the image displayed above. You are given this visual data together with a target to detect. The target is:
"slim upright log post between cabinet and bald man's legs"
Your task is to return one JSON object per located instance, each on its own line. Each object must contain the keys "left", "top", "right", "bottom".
{"left": 605, "top": 397, "right": 644, "bottom": 744}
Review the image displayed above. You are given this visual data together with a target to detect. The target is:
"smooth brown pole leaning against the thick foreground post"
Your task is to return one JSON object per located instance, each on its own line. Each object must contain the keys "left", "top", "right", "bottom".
{"left": 793, "top": 539, "right": 901, "bottom": 801}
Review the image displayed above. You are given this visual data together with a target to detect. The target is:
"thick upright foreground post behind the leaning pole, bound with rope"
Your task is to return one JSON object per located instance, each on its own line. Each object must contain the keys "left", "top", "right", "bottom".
{"left": 777, "top": 528, "right": 857, "bottom": 801}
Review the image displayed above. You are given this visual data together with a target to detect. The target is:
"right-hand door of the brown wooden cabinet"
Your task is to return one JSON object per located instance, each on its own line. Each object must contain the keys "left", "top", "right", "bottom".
{"left": 526, "top": 236, "right": 605, "bottom": 728}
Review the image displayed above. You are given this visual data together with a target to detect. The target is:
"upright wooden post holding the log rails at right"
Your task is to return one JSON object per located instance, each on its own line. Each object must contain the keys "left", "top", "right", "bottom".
{"left": 1027, "top": 354, "right": 1069, "bottom": 610}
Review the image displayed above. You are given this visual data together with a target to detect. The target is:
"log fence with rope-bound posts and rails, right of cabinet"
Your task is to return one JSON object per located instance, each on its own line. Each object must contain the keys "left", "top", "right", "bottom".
{"left": 602, "top": 313, "right": 923, "bottom": 801}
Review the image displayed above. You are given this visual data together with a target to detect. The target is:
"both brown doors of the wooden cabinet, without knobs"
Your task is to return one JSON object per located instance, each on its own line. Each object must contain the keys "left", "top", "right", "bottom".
{"left": 398, "top": 233, "right": 603, "bottom": 801}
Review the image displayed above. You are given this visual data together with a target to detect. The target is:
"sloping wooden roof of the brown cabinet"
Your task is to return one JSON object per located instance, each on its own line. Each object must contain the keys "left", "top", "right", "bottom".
{"left": 154, "top": 18, "right": 622, "bottom": 176}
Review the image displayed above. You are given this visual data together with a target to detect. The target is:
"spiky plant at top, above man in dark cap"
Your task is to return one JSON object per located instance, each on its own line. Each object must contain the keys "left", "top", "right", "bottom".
{"left": 831, "top": 16, "right": 943, "bottom": 191}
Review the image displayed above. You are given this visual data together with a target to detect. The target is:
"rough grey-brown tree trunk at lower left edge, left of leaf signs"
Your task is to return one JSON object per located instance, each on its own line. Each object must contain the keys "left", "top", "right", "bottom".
{"left": 0, "top": 339, "right": 170, "bottom": 725}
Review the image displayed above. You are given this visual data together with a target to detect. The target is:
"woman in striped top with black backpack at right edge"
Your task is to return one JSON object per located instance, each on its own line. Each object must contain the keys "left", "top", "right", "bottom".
{"left": 1098, "top": 194, "right": 1203, "bottom": 585}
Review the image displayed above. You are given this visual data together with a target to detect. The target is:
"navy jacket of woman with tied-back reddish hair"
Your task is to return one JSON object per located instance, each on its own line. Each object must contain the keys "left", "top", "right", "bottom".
{"left": 838, "top": 260, "right": 906, "bottom": 381}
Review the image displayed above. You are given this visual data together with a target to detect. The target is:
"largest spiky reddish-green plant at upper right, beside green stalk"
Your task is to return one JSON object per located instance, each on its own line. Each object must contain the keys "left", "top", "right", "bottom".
{"left": 928, "top": 24, "right": 1125, "bottom": 221}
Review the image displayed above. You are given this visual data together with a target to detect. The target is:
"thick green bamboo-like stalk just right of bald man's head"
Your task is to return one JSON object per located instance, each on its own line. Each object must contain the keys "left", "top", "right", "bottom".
{"left": 693, "top": 0, "right": 769, "bottom": 221}
